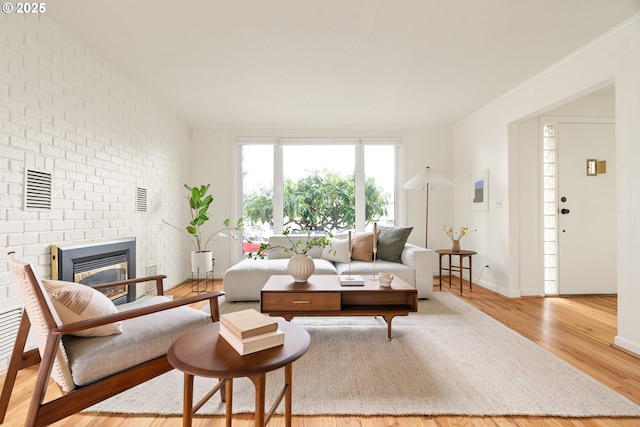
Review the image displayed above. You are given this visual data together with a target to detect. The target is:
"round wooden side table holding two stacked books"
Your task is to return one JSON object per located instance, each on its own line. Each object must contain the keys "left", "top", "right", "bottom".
{"left": 167, "top": 319, "right": 311, "bottom": 427}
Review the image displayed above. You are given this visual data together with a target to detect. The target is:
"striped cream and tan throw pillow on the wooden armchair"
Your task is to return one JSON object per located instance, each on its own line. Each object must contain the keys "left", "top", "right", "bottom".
{"left": 42, "top": 280, "right": 122, "bottom": 337}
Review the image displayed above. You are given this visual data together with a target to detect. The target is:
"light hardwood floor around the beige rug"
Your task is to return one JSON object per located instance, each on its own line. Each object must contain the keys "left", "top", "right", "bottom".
{"left": 3, "top": 279, "right": 640, "bottom": 427}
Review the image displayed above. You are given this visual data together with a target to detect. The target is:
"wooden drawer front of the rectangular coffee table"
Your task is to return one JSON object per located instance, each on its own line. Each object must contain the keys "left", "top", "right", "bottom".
{"left": 262, "top": 292, "right": 340, "bottom": 313}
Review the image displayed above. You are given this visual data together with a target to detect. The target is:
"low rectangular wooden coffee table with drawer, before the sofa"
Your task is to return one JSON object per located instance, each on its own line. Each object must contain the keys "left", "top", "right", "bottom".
{"left": 260, "top": 274, "right": 418, "bottom": 340}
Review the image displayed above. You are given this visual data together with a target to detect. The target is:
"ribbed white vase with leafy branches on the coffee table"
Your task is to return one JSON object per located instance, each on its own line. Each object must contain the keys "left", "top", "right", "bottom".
{"left": 247, "top": 227, "right": 335, "bottom": 283}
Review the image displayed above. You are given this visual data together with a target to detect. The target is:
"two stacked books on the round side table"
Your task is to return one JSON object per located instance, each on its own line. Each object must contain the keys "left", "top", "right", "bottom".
{"left": 220, "top": 309, "right": 284, "bottom": 356}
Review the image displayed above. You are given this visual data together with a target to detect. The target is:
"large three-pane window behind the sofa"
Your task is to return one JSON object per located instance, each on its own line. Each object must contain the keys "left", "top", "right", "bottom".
{"left": 237, "top": 138, "right": 401, "bottom": 254}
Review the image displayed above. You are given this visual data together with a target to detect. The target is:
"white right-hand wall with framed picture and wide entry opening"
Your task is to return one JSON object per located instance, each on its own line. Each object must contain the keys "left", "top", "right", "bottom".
{"left": 453, "top": 15, "right": 640, "bottom": 353}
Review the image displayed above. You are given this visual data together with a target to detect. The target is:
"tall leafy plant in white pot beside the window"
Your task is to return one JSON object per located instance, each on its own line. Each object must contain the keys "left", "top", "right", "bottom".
{"left": 162, "top": 184, "right": 243, "bottom": 273}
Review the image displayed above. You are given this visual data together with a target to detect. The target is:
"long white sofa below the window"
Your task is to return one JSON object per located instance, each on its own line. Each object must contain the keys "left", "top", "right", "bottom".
{"left": 223, "top": 236, "right": 433, "bottom": 301}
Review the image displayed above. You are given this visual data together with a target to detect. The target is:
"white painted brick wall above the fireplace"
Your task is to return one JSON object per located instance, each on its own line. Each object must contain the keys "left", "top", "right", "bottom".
{"left": 0, "top": 14, "right": 191, "bottom": 369}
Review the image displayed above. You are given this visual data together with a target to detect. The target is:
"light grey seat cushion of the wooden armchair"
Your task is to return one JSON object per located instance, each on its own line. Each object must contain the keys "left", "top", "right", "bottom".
{"left": 63, "top": 296, "right": 211, "bottom": 386}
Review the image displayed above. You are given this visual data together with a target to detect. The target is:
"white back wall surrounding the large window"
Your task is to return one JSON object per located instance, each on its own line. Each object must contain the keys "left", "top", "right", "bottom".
{"left": 191, "top": 128, "right": 453, "bottom": 277}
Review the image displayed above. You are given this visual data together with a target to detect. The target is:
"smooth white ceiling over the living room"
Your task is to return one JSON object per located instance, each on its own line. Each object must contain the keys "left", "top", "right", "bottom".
{"left": 46, "top": 0, "right": 640, "bottom": 127}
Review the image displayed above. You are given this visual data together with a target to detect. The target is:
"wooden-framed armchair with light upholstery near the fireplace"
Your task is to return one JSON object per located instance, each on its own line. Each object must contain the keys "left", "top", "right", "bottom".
{"left": 0, "top": 253, "right": 224, "bottom": 426}
